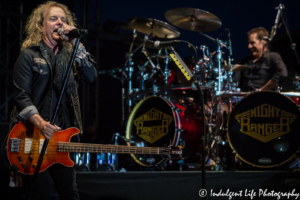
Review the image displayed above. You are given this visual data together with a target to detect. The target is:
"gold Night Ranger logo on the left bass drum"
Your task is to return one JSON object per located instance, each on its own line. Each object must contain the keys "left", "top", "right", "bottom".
{"left": 133, "top": 108, "right": 173, "bottom": 144}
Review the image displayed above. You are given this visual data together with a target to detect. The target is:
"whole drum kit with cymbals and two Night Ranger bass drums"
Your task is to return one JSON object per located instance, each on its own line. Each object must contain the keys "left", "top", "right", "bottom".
{"left": 100, "top": 8, "right": 300, "bottom": 170}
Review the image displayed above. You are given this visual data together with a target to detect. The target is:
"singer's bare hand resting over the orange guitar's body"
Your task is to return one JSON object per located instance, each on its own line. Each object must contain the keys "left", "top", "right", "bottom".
{"left": 28, "top": 114, "right": 61, "bottom": 140}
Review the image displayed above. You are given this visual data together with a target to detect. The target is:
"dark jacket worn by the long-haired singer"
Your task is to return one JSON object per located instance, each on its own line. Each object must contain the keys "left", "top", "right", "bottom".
{"left": 13, "top": 41, "right": 97, "bottom": 128}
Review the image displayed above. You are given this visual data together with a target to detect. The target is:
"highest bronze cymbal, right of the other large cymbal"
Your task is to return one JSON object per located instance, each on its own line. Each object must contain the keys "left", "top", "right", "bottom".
{"left": 165, "top": 8, "right": 222, "bottom": 32}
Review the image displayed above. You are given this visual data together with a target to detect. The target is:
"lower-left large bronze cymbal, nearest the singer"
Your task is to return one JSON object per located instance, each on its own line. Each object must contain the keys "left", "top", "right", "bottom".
{"left": 127, "top": 17, "right": 180, "bottom": 38}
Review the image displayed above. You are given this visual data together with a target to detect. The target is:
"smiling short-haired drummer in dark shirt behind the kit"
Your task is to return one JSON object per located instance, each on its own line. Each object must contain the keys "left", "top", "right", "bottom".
{"left": 233, "top": 27, "right": 287, "bottom": 92}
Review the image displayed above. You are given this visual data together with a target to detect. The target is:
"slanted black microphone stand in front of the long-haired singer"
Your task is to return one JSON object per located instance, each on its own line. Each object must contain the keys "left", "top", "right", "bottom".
{"left": 27, "top": 31, "right": 87, "bottom": 200}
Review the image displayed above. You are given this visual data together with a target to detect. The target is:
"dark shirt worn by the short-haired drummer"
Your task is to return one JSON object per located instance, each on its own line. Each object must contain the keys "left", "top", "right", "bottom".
{"left": 233, "top": 51, "right": 287, "bottom": 92}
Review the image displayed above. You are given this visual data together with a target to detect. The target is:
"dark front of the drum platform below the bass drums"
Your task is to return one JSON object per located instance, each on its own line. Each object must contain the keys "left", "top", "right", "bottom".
{"left": 77, "top": 171, "right": 300, "bottom": 200}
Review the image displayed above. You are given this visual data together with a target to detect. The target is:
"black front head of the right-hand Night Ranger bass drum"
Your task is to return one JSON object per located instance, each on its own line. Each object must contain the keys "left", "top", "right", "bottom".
{"left": 227, "top": 91, "right": 300, "bottom": 168}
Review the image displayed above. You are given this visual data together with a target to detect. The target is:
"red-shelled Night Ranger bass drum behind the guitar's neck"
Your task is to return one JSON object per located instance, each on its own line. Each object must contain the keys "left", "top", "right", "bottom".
{"left": 126, "top": 96, "right": 201, "bottom": 167}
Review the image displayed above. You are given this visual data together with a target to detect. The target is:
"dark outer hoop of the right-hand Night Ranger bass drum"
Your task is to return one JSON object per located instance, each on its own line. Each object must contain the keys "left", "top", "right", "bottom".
{"left": 226, "top": 90, "right": 300, "bottom": 168}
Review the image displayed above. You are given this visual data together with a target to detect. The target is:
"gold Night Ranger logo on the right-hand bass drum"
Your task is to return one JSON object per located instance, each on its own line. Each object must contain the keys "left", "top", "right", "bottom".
{"left": 235, "top": 104, "right": 297, "bottom": 142}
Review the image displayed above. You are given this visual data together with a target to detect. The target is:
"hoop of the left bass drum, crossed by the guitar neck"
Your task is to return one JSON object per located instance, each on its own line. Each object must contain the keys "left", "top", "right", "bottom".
{"left": 125, "top": 95, "right": 180, "bottom": 167}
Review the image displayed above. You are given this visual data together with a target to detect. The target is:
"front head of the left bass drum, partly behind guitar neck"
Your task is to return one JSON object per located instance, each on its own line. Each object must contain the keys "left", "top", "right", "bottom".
{"left": 126, "top": 96, "right": 177, "bottom": 167}
